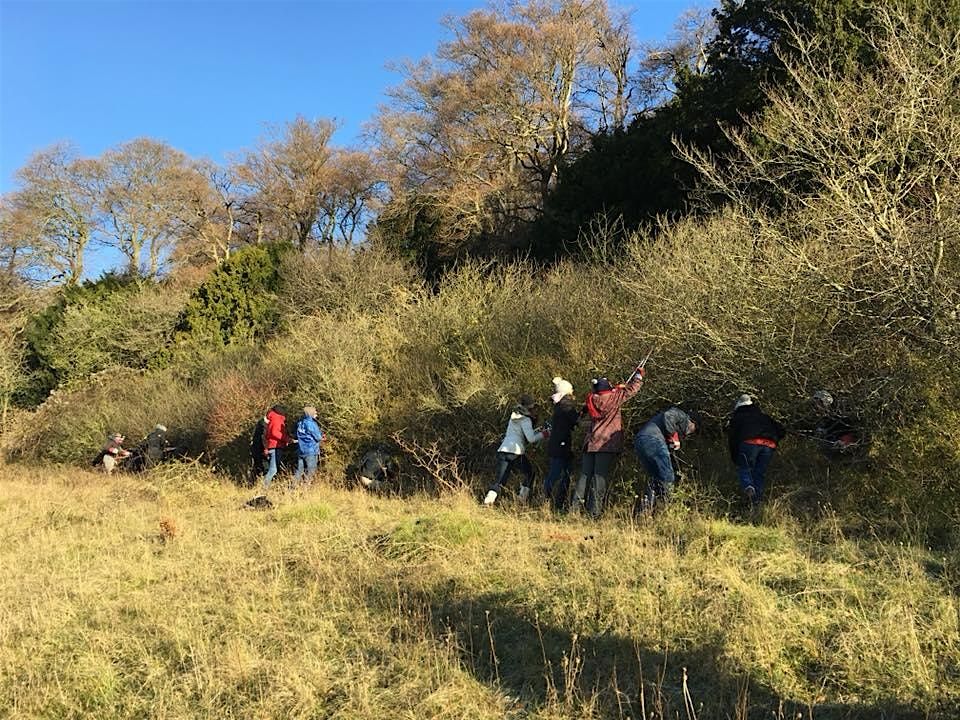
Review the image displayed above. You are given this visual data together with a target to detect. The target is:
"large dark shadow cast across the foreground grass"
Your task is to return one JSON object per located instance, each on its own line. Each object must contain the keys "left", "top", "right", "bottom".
{"left": 408, "top": 594, "right": 936, "bottom": 720}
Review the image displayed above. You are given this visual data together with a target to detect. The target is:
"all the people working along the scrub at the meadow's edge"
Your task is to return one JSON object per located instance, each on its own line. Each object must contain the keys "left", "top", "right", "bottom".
{"left": 93, "top": 372, "right": 864, "bottom": 518}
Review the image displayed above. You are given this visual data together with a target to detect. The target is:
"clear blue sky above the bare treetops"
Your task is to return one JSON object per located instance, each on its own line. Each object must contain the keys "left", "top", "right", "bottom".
{"left": 0, "top": 0, "right": 706, "bottom": 192}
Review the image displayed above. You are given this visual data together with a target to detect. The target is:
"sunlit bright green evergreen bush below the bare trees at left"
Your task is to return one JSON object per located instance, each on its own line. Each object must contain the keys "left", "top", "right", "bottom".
{"left": 172, "top": 244, "right": 290, "bottom": 354}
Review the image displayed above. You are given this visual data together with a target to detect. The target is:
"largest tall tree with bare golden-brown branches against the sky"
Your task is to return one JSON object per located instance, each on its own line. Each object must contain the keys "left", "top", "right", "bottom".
{"left": 376, "top": 0, "right": 631, "bottom": 248}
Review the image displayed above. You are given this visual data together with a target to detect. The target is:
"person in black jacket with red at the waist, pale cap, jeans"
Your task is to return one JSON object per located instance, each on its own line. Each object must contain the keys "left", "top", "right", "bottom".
{"left": 728, "top": 395, "right": 787, "bottom": 505}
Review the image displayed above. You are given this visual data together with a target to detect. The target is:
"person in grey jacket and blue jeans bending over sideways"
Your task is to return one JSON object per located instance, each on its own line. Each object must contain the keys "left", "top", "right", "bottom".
{"left": 633, "top": 406, "right": 700, "bottom": 514}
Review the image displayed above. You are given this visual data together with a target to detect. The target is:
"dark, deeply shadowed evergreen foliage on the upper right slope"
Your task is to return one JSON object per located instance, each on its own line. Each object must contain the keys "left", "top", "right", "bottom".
{"left": 530, "top": 0, "right": 916, "bottom": 258}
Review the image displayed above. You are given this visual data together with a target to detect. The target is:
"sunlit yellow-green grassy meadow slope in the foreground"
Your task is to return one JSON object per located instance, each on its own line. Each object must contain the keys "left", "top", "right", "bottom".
{"left": 0, "top": 467, "right": 960, "bottom": 719}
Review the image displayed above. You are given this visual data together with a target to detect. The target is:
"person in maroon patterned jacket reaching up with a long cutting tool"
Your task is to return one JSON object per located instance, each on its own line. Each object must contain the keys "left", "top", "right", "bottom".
{"left": 570, "top": 366, "right": 645, "bottom": 518}
